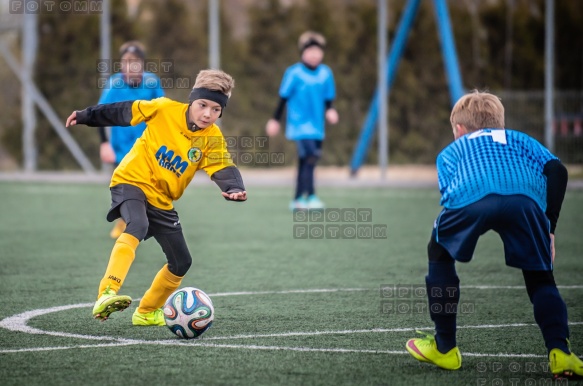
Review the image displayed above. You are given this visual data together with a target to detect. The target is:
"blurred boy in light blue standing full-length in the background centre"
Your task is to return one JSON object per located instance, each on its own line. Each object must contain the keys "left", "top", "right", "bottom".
{"left": 266, "top": 31, "right": 338, "bottom": 210}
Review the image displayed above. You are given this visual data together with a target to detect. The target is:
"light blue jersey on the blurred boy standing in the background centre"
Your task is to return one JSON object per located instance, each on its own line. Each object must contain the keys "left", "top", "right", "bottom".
{"left": 279, "top": 63, "right": 336, "bottom": 141}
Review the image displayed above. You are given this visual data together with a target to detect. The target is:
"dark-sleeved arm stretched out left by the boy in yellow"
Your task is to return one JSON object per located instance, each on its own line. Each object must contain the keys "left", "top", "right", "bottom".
{"left": 65, "top": 101, "right": 134, "bottom": 127}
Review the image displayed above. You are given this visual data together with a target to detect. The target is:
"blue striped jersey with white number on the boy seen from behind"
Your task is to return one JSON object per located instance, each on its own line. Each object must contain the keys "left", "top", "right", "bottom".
{"left": 437, "top": 129, "right": 557, "bottom": 211}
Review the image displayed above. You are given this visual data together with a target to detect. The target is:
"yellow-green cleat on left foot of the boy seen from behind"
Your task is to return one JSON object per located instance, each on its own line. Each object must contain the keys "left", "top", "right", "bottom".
{"left": 405, "top": 331, "right": 462, "bottom": 370}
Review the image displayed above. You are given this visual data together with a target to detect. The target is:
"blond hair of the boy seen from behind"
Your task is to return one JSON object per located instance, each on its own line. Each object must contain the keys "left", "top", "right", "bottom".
{"left": 449, "top": 90, "right": 504, "bottom": 132}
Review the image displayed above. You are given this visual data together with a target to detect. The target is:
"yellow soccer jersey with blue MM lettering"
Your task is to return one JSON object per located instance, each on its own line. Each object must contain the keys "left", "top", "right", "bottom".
{"left": 110, "top": 97, "right": 234, "bottom": 210}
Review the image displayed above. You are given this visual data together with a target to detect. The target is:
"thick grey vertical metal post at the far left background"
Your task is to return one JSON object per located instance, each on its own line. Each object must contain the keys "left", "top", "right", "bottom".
{"left": 20, "top": 12, "right": 38, "bottom": 173}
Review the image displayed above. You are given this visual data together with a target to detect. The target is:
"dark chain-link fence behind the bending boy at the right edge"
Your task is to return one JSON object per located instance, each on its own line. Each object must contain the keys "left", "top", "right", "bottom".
{"left": 499, "top": 91, "right": 583, "bottom": 164}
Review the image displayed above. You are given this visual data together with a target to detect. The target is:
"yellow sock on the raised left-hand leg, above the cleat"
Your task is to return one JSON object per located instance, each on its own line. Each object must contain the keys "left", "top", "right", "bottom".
{"left": 97, "top": 233, "right": 140, "bottom": 298}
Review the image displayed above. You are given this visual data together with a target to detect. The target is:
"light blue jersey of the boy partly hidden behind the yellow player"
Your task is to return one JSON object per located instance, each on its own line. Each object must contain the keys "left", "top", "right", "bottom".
{"left": 99, "top": 72, "right": 164, "bottom": 164}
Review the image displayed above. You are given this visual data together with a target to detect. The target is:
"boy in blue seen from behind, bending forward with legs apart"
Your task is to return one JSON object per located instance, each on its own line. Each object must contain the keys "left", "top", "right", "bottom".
{"left": 406, "top": 91, "right": 583, "bottom": 377}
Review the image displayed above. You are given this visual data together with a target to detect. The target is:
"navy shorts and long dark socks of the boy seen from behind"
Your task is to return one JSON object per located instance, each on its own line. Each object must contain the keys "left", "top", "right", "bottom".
{"left": 425, "top": 194, "right": 569, "bottom": 353}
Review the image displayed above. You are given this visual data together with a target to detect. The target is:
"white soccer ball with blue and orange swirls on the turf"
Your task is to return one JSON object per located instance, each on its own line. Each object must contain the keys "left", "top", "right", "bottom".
{"left": 164, "top": 287, "right": 215, "bottom": 339}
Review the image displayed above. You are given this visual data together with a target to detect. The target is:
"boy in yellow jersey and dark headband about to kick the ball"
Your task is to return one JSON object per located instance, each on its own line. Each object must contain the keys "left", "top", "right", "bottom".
{"left": 66, "top": 70, "right": 247, "bottom": 326}
